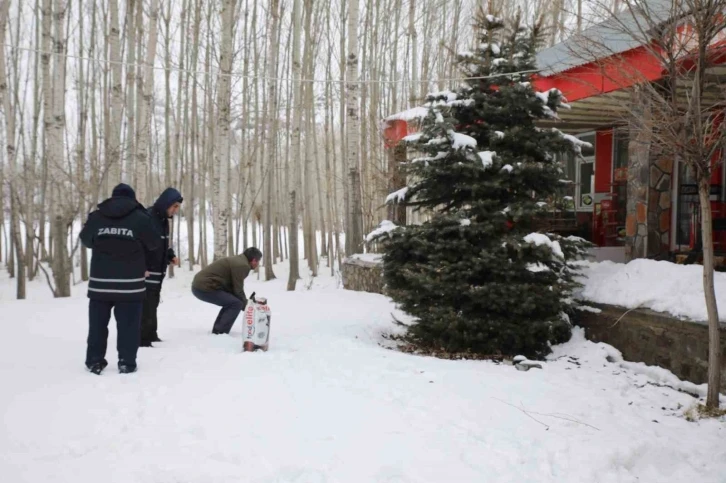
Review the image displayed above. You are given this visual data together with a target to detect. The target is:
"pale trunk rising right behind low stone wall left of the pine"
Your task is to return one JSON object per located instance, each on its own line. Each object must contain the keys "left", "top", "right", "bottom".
{"left": 346, "top": 0, "right": 363, "bottom": 255}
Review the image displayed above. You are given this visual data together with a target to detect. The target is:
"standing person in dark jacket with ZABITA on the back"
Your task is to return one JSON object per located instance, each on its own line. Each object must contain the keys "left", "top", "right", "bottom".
{"left": 80, "top": 183, "right": 161, "bottom": 374}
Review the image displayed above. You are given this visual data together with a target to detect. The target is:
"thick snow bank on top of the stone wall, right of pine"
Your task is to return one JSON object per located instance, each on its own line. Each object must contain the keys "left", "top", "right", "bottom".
{"left": 579, "top": 259, "right": 726, "bottom": 322}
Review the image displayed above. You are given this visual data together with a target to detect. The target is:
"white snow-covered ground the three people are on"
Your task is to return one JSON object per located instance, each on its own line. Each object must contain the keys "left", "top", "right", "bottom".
{"left": 0, "top": 269, "right": 726, "bottom": 483}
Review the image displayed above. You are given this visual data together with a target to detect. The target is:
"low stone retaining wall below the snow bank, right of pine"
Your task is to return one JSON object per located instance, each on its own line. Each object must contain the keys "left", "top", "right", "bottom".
{"left": 573, "top": 304, "right": 726, "bottom": 387}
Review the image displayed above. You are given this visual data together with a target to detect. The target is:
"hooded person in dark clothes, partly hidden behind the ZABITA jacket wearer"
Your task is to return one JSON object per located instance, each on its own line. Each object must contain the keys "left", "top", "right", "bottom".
{"left": 141, "top": 188, "right": 184, "bottom": 347}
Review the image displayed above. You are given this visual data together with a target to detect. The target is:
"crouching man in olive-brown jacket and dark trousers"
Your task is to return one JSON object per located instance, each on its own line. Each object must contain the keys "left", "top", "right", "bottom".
{"left": 192, "top": 247, "right": 262, "bottom": 334}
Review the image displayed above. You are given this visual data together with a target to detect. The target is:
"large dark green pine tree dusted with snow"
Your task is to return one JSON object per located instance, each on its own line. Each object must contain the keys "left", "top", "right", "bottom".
{"left": 369, "top": 15, "right": 586, "bottom": 358}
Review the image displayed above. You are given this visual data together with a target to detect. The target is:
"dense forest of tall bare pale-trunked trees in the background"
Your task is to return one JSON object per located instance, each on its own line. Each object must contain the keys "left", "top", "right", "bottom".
{"left": 0, "top": 0, "right": 620, "bottom": 298}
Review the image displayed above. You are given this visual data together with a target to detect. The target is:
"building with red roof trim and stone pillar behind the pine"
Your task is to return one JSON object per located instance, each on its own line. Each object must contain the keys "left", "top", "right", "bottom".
{"left": 385, "top": 0, "right": 726, "bottom": 261}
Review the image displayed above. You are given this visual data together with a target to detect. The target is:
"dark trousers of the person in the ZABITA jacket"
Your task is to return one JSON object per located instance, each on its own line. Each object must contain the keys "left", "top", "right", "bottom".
{"left": 86, "top": 300, "right": 143, "bottom": 368}
